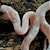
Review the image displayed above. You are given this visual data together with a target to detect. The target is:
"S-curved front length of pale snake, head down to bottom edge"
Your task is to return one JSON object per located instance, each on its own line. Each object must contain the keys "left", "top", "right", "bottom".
{"left": 1, "top": 5, "right": 39, "bottom": 50}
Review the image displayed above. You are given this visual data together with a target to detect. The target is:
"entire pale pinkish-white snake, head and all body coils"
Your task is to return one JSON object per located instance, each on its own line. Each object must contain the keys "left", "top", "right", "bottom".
{"left": 1, "top": 1, "right": 50, "bottom": 50}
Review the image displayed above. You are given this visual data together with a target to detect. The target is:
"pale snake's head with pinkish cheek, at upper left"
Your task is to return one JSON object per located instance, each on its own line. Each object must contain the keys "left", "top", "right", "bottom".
{"left": 1, "top": 5, "right": 18, "bottom": 21}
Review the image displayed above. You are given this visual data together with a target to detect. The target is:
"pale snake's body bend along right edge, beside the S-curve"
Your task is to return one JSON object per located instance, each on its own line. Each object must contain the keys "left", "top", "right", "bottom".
{"left": 36, "top": 1, "right": 50, "bottom": 50}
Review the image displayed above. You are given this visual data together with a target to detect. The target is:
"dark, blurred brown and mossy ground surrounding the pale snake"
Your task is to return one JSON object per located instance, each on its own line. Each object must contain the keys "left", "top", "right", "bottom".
{"left": 0, "top": 0, "right": 50, "bottom": 50}
